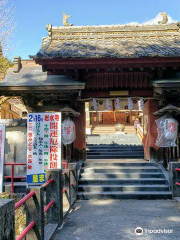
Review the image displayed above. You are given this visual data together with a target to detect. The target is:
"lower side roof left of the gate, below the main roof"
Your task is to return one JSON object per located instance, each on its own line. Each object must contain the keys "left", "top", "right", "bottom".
{"left": 0, "top": 65, "right": 85, "bottom": 89}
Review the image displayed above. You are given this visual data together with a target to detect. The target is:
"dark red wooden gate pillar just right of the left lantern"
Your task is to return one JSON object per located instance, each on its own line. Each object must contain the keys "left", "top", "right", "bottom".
{"left": 73, "top": 102, "right": 86, "bottom": 160}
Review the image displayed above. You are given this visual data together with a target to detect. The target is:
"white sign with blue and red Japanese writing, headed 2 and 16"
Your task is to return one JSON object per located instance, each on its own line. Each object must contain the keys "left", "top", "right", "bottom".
{"left": 27, "top": 113, "right": 61, "bottom": 184}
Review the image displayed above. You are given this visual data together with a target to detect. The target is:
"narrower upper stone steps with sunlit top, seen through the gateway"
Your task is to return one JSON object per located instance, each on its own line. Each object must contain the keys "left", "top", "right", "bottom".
{"left": 87, "top": 134, "right": 144, "bottom": 159}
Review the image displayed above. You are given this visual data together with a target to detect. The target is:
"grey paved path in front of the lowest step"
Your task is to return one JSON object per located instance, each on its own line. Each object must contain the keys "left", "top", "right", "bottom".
{"left": 53, "top": 200, "right": 180, "bottom": 240}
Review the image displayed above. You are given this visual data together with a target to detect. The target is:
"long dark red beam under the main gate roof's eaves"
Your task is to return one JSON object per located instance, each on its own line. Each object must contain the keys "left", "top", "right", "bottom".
{"left": 36, "top": 57, "right": 180, "bottom": 69}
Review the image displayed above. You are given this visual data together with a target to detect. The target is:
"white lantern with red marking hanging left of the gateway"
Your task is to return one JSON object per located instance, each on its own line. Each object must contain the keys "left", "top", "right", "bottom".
{"left": 62, "top": 117, "right": 76, "bottom": 146}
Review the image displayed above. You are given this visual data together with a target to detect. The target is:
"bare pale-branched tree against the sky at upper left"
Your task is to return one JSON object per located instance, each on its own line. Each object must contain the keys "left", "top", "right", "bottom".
{"left": 0, "top": 0, "right": 15, "bottom": 51}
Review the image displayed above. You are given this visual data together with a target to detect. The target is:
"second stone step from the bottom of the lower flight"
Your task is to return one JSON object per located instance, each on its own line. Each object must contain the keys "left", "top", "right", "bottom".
{"left": 78, "top": 184, "right": 169, "bottom": 192}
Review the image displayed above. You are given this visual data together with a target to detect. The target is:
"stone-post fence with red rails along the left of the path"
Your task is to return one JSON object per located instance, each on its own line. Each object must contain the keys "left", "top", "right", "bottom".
{"left": 0, "top": 163, "right": 77, "bottom": 240}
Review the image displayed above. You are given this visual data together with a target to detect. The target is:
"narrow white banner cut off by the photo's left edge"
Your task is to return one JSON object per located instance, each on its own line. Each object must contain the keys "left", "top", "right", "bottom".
{"left": 0, "top": 125, "right": 6, "bottom": 193}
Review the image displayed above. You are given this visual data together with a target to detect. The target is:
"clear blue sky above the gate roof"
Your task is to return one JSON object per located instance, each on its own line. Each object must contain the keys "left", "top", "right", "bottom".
{"left": 4, "top": 0, "right": 180, "bottom": 59}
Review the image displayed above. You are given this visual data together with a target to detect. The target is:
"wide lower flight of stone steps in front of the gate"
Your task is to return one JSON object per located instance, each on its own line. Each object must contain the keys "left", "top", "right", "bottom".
{"left": 78, "top": 159, "right": 172, "bottom": 200}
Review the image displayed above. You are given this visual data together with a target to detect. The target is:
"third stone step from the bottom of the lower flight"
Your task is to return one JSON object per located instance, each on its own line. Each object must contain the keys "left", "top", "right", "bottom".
{"left": 79, "top": 178, "right": 166, "bottom": 185}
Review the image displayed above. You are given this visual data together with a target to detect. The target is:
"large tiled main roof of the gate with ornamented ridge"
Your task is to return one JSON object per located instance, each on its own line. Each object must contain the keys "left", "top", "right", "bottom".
{"left": 32, "top": 23, "right": 180, "bottom": 59}
